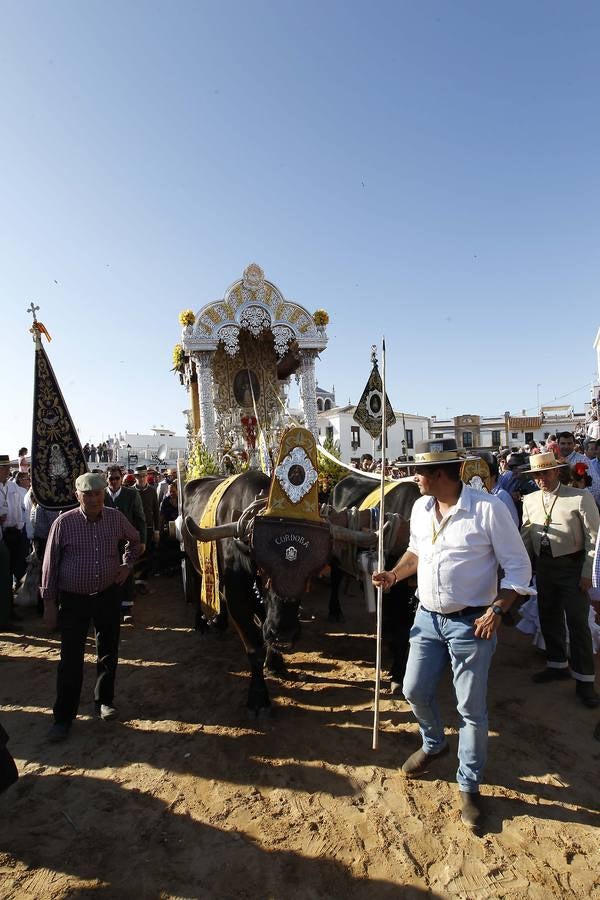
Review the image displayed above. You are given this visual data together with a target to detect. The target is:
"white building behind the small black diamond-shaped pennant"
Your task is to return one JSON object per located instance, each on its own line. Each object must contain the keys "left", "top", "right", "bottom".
{"left": 317, "top": 405, "right": 429, "bottom": 463}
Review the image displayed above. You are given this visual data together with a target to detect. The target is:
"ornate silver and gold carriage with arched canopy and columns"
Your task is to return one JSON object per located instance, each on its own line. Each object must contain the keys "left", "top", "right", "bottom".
{"left": 181, "top": 263, "right": 327, "bottom": 464}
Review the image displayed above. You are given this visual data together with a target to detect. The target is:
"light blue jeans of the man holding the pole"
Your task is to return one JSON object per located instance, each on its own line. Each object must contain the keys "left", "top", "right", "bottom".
{"left": 402, "top": 606, "right": 497, "bottom": 792}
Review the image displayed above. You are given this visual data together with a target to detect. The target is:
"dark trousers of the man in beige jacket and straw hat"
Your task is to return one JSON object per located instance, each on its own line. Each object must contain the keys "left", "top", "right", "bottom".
{"left": 536, "top": 554, "right": 594, "bottom": 682}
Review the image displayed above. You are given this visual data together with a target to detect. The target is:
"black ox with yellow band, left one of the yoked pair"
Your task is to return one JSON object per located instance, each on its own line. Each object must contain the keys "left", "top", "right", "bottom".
{"left": 182, "top": 469, "right": 376, "bottom": 715}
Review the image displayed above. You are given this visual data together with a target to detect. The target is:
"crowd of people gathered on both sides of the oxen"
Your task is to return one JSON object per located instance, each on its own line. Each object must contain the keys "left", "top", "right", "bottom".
{"left": 0, "top": 432, "right": 600, "bottom": 829}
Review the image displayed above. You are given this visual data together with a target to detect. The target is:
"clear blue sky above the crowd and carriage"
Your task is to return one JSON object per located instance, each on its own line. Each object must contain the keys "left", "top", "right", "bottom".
{"left": 0, "top": 0, "right": 600, "bottom": 454}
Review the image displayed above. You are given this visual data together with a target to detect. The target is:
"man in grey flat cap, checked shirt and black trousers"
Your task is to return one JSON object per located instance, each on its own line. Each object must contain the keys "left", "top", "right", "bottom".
{"left": 40, "top": 472, "right": 140, "bottom": 741}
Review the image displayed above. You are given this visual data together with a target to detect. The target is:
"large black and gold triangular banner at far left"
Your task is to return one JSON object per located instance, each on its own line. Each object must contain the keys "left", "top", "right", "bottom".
{"left": 31, "top": 342, "right": 88, "bottom": 509}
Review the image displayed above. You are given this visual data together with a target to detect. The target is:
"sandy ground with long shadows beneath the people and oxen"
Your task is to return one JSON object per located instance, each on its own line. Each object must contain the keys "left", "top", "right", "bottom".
{"left": 0, "top": 579, "right": 600, "bottom": 900}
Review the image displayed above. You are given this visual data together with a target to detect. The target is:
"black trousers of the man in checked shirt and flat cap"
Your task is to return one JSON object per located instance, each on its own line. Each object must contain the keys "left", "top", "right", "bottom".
{"left": 54, "top": 585, "right": 121, "bottom": 725}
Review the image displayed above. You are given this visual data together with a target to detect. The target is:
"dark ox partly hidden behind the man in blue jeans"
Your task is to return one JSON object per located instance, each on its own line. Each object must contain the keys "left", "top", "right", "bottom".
{"left": 328, "top": 472, "right": 420, "bottom": 693}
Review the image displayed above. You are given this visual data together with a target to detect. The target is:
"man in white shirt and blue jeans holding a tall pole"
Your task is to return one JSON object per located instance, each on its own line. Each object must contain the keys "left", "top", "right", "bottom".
{"left": 373, "top": 440, "right": 534, "bottom": 829}
